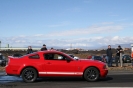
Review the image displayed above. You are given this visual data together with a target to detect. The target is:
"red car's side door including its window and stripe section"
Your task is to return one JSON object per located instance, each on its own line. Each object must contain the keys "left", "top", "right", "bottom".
{"left": 44, "top": 53, "right": 80, "bottom": 76}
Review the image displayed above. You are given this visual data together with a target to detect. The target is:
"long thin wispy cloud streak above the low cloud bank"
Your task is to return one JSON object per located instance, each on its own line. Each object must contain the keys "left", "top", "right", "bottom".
{"left": 29, "top": 22, "right": 127, "bottom": 38}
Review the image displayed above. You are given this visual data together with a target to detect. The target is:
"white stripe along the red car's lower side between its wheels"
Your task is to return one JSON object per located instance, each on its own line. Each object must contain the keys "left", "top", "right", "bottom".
{"left": 39, "top": 72, "right": 83, "bottom": 75}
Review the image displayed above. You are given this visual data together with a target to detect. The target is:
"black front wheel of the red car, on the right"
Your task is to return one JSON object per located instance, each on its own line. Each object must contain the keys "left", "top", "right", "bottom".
{"left": 84, "top": 67, "right": 99, "bottom": 82}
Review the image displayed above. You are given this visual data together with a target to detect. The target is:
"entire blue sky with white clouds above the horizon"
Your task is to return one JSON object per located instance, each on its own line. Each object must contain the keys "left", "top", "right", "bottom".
{"left": 0, "top": 0, "right": 133, "bottom": 49}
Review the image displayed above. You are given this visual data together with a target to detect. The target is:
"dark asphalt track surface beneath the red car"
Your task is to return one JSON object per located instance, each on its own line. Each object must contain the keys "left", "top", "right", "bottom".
{"left": 0, "top": 71, "right": 133, "bottom": 88}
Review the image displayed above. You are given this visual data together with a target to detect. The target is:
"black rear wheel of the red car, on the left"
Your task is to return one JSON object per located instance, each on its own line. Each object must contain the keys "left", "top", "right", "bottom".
{"left": 21, "top": 67, "right": 37, "bottom": 83}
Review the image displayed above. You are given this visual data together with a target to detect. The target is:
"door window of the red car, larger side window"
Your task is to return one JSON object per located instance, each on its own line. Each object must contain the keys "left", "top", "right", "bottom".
{"left": 44, "top": 54, "right": 66, "bottom": 60}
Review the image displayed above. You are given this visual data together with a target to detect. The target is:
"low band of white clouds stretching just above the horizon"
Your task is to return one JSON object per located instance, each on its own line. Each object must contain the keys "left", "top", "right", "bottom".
{"left": 2, "top": 36, "right": 133, "bottom": 49}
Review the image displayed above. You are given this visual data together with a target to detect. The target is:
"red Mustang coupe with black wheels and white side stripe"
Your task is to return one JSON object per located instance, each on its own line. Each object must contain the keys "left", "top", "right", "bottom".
{"left": 6, "top": 50, "right": 108, "bottom": 82}
